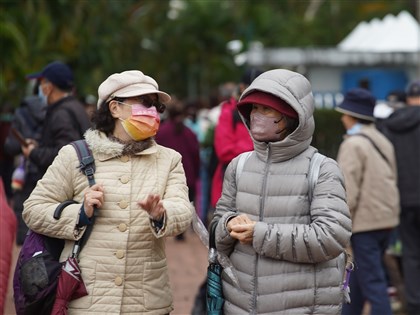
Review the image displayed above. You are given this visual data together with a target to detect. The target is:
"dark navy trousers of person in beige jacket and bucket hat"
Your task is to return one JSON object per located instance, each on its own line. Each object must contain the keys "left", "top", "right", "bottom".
{"left": 342, "top": 230, "right": 392, "bottom": 315}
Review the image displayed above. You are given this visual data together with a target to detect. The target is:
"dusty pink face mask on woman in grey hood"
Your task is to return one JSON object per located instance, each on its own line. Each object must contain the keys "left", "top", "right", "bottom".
{"left": 250, "top": 112, "right": 286, "bottom": 142}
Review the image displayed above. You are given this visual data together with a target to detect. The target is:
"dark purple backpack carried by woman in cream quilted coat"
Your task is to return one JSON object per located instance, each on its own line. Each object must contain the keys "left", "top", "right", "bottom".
{"left": 13, "top": 140, "right": 96, "bottom": 315}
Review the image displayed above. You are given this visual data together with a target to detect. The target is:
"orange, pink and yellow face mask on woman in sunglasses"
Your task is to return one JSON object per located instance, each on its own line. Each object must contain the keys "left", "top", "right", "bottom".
{"left": 119, "top": 102, "right": 160, "bottom": 141}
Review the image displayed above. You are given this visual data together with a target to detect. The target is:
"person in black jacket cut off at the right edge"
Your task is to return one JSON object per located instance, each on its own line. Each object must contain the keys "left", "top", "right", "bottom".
{"left": 380, "top": 80, "right": 420, "bottom": 315}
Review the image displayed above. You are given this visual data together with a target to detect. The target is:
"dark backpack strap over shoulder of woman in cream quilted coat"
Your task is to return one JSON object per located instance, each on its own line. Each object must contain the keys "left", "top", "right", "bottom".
{"left": 71, "top": 139, "right": 98, "bottom": 257}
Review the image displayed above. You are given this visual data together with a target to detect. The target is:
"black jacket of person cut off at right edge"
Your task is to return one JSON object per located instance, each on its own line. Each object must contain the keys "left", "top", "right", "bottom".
{"left": 378, "top": 106, "right": 420, "bottom": 207}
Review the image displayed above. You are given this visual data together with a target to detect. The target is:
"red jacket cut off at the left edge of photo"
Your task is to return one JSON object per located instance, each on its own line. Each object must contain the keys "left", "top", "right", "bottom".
{"left": 0, "top": 176, "right": 17, "bottom": 314}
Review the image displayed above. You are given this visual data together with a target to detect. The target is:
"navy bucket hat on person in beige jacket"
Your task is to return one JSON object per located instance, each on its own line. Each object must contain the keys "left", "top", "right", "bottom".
{"left": 335, "top": 88, "right": 376, "bottom": 121}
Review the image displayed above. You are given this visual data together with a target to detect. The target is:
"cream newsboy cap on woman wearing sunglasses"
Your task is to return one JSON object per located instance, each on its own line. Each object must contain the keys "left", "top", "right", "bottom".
{"left": 97, "top": 70, "right": 171, "bottom": 108}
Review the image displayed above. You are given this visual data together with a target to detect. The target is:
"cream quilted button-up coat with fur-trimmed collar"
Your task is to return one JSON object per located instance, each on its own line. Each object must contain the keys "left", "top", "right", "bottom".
{"left": 23, "top": 130, "right": 192, "bottom": 315}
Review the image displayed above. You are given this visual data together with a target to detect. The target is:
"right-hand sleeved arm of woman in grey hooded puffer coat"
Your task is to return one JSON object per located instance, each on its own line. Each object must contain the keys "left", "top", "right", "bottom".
{"left": 253, "top": 159, "right": 351, "bottom": 263}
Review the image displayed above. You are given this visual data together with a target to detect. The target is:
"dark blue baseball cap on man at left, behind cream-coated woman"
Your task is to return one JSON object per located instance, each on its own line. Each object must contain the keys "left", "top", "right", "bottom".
{"left": 26, "top": 61, "right": 74, "bottom": 90}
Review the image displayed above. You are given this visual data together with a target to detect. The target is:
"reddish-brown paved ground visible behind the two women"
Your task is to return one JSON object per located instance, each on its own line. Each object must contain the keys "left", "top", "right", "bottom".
{"left": 4, "top": 230, "right": 207, "bottom": 315}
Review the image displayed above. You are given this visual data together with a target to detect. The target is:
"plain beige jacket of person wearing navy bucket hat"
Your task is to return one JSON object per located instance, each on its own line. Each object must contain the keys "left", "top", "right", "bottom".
{"left": 337, "top": 124, "right": 400, "bottom": 233}
